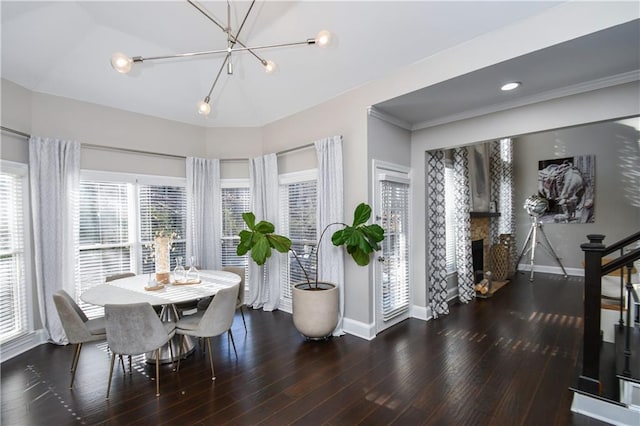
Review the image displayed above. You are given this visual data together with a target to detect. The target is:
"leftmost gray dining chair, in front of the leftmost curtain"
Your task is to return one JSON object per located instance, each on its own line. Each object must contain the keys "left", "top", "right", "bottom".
{"left": 53, "top": 290, "right": 107, "bottom": 389}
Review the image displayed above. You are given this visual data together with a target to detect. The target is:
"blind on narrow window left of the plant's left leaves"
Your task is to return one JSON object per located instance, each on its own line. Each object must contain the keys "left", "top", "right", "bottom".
{"left": 222, "top": 186, "right": 251, "bottom": 271}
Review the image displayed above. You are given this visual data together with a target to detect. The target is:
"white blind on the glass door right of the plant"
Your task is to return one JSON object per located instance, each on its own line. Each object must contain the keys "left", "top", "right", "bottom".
{"left": 380, "top": 180, "right": 409, "bottom": 321}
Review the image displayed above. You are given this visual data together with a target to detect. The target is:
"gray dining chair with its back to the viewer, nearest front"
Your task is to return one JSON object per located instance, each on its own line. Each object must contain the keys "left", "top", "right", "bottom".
{"left": 104, "top": 303, "right": 176, "bottom": 399}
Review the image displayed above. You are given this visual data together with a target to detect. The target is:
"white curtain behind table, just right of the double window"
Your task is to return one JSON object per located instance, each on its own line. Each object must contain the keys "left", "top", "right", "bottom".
{"left": 185, "top": 157, "right": 222, "bottom": 269}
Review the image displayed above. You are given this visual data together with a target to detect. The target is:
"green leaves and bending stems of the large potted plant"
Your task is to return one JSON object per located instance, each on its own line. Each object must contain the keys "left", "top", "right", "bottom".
{"left": 236, "top": 203, "right": 384, "bottom": 287}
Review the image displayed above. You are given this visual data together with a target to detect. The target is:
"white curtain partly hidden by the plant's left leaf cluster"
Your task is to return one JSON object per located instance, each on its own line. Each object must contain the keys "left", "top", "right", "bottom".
{"left": 247, "top": 154, "right": 284, "bottom": 311}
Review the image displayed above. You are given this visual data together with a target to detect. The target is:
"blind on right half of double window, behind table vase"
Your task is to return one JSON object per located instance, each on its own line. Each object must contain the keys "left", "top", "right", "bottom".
{"left": 138, "top": 185, "right": 186, "bottom": 274}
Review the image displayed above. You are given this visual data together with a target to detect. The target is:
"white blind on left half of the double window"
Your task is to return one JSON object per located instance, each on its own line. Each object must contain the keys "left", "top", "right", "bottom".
{"left": 75, "top": 180, "right": 133, "bottom": 318}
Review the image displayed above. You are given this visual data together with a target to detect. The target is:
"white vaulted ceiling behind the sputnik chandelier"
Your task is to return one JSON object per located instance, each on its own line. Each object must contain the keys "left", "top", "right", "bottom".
{"left": 1, "top": 0, "right": 559, "bottom": 127}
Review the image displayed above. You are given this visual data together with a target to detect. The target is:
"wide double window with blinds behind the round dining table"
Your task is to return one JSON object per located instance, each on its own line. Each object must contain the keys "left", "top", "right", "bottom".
{"left": 75, "top": 172, "right": 186, "bottom": 318}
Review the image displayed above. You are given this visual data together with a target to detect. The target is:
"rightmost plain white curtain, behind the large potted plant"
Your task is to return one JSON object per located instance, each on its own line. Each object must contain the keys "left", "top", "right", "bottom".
{"left": 315, "top": 136, "right": 344, "bottom": 336}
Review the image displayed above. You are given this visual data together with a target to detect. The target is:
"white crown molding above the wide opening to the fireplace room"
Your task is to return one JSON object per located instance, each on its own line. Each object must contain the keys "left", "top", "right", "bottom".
{"left": 412, "top": 70, "right": 640, "bottom": 131}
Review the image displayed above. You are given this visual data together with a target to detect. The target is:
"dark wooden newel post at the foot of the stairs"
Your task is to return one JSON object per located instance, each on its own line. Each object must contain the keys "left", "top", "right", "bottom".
{"left": 578, "top": 234, "right": 606, "bottom": 395}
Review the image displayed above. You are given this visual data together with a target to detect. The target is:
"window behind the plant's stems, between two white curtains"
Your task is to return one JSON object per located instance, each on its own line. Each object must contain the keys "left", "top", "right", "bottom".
{"left": 277, "top": 170, "right": 317, "bottom": 299}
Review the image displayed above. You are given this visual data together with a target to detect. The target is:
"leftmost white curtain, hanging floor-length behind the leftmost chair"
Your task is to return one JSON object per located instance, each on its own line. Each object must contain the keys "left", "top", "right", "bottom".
{"left": 29, "top": 136, "right": 80, "bottom": 344}
